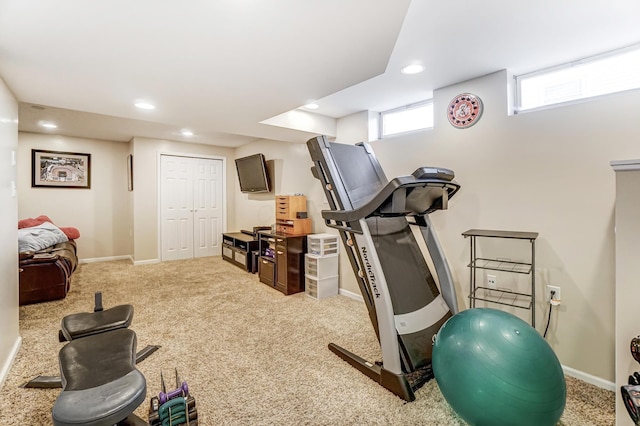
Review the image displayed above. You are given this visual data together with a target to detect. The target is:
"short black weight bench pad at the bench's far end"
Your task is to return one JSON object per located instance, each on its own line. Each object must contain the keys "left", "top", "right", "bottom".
{"left": 60, "top": 305, "right": 133, "bottom": 341}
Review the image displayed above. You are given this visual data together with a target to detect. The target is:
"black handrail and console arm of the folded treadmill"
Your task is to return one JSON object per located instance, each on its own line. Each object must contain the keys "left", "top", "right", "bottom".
{"left": 321, "top": 172, "right": 460, "bottom": 222}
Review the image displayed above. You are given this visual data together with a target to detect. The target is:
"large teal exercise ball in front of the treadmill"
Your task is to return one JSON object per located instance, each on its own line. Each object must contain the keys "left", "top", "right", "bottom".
{"left": 432, "top": 308, "right": 567, "bottom": 426}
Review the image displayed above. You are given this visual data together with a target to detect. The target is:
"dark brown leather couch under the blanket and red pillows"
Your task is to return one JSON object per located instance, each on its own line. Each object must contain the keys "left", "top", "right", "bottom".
{"left": 19, "top": 240, "right": 78, "bottom": 305}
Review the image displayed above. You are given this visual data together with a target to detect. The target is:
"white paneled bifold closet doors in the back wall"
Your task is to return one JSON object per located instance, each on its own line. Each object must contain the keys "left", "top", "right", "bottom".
{"left": 160, "top": 155, "right": 224, "bottom": 261}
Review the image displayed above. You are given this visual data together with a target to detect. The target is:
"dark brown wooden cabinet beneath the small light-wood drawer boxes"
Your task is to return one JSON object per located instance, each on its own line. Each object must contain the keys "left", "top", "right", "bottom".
{"left": 258, "top": 231, "right": 307, "bottom": 295}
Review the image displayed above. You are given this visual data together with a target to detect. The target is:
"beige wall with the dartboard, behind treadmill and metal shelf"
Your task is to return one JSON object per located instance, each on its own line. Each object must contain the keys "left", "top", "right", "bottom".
{"left": 352, "top": 72, "right": 640, "bottom": 382}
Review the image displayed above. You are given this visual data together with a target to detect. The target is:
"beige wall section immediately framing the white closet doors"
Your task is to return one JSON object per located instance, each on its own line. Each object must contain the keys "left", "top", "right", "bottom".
{"left": 131, "top": 138, "right": 237, "bottom": 263}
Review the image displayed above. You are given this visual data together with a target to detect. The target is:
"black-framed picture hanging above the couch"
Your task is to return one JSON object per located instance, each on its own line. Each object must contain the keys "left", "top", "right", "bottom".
{"left": 31, "top": 149, "right": 91, "bottom": 188}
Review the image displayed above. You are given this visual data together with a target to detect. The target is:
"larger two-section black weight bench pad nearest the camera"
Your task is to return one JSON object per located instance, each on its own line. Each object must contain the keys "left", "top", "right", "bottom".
{"left": 52, "top": 328, "right": 147, "bottom": 426}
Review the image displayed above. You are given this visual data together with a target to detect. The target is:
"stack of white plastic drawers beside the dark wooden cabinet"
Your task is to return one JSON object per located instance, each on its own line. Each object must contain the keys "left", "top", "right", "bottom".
{"left": 304, "top": 234, "right": 339, "bottom": 299}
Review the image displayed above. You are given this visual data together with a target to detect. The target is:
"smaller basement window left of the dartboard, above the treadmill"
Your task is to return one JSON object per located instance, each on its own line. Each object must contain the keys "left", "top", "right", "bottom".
{"left": 380, "top": 99, "right": 433, "bottom": 139}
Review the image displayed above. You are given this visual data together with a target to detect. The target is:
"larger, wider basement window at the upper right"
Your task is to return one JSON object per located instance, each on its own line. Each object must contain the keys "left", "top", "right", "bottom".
{"left": 515, "top": 46, "right": 640, "bottom": 112}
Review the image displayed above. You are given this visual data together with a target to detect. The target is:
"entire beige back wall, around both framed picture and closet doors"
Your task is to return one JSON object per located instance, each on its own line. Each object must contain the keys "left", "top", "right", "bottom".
{"left": 18, "top": 132, "right": 235, "bottom": 262}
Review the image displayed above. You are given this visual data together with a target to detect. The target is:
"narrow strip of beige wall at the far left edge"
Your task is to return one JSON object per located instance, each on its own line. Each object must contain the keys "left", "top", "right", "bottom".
{"left": 0, "top": 78, "right": 20, "bottom": 388}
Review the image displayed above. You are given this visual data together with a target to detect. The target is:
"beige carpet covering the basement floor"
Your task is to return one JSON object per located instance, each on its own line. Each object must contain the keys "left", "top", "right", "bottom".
{"left": 0, "top": 257, "right": 614, "bottom": 426}
